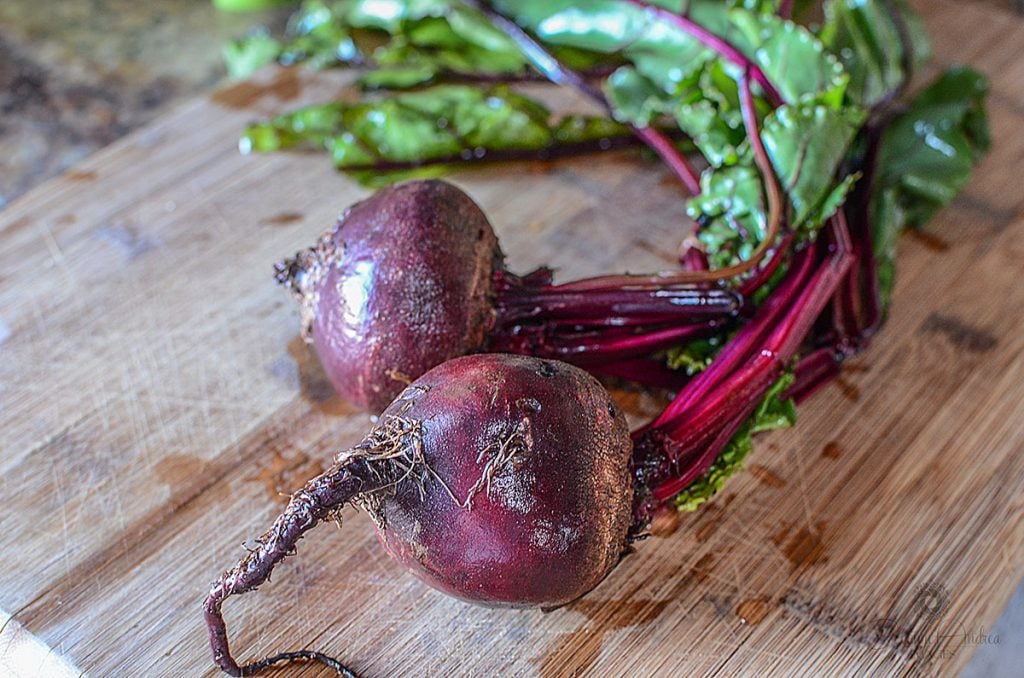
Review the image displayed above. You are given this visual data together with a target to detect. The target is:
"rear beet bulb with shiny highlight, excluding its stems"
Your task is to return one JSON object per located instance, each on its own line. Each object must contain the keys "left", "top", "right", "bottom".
{"left": 276, "top": 181, "right": 502, "bottom": 412}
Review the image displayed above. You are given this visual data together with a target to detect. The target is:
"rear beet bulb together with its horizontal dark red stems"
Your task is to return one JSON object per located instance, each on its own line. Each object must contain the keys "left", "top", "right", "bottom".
{"left": 276, "top": 180, "right": 740, "bottom": 412}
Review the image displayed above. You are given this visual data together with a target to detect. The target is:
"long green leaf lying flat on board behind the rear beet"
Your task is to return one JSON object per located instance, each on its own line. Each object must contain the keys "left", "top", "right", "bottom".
{"left": 240, "top": 85, "right": 629, "bottom": 185}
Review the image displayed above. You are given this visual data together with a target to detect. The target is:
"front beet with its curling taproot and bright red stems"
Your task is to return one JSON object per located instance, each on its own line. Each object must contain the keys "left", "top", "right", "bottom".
{"left": 204, "top": 204, "right": 852, "bottom": 676}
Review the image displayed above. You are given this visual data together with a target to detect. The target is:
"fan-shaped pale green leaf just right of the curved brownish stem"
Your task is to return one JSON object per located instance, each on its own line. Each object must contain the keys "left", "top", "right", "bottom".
{"left": 761, "top": 104, "right": 864, "bottom": 227}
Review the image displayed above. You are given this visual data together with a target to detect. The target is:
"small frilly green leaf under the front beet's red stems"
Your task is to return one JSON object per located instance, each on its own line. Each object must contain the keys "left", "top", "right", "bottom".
{"left": 674, "top": 374, "right": 797, "bottom": 511}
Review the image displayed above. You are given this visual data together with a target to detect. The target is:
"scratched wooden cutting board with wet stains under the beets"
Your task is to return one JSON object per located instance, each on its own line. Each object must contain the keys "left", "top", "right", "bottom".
{"left": 0, "top": 2, "right": 1024, "bottom": 677}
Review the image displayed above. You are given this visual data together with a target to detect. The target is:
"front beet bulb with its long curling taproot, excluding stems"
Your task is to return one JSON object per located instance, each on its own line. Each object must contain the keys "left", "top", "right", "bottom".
{"left": 204, "top": 353, "right": 634, "bottom": 676}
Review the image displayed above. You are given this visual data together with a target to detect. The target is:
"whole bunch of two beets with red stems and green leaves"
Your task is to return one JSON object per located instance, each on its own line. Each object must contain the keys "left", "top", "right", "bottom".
{"left": 204, "top": 0, "right": 987, "bottom": 675}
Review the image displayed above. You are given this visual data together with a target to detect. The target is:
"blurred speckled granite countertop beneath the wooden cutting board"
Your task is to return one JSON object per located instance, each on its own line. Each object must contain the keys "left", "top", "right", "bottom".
{"left": 0, "top": 0, "right": 1024, "bottom": 677}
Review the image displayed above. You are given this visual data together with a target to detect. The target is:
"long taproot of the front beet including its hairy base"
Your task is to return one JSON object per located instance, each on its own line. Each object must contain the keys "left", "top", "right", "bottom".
{"left": 203, "top": 417, "right": 423, "bottom": 677}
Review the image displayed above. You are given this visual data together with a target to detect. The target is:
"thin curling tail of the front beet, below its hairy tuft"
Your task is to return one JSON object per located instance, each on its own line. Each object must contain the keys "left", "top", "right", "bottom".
{"left": 203, "top": 460, "right": 381, "bottom": 678}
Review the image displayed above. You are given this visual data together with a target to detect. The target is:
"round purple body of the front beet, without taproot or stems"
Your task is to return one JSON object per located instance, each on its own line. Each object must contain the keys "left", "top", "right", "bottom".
{"left": 364, "top": 353, "right": 633, "bottom": 606}
